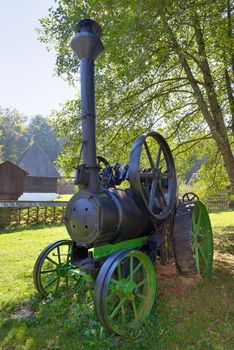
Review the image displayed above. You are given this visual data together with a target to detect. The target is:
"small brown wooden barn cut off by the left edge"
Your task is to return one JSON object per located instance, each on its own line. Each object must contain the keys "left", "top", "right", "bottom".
{"left": 0, "top": 160, "right": 28, "bottom": 200}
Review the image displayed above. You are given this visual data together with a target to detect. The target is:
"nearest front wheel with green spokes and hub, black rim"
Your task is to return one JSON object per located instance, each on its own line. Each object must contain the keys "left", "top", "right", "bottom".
{"left": 94, "top": 250, "right": 156, "bottom": 335}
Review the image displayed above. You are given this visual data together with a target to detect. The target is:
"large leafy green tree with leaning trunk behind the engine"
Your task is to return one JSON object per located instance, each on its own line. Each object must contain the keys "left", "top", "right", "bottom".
{"left": 40, "top": 0, "right": 234, "bottom": 191}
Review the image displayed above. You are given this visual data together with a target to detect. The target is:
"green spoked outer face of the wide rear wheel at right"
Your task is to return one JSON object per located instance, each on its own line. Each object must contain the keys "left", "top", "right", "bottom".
{"left": 192, "top": 202, "right": 214, "bottom": 277}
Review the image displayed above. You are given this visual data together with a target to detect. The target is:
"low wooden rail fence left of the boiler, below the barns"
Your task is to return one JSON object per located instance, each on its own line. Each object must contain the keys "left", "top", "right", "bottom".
{"left": 0, "top": 201, "right": 67, "bottom": 228}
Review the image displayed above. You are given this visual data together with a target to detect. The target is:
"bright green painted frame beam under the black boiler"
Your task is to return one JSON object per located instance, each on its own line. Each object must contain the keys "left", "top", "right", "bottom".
{"left": 89, "top": 236, "right": 148, "bottom": 259}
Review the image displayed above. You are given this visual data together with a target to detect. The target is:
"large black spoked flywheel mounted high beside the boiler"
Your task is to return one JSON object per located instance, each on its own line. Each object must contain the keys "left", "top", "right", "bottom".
{"left": 129, "top": 132, "right": 176, "bottom": 219}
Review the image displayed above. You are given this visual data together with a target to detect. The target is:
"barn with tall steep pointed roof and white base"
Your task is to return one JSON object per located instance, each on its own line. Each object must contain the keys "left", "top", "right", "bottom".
{"left": 18, "top": 143, "right": 60, "bottom": 200}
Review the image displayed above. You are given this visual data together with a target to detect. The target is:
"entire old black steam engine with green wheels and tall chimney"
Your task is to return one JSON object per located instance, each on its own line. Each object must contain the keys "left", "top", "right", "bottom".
{"left": 34, "top": 19, "right": 213, "bottom": 334}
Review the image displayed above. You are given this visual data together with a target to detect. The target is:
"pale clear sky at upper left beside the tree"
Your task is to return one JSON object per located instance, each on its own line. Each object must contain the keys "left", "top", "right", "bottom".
{"left": 0, "top": 0, "right": 75, "bottom": 117}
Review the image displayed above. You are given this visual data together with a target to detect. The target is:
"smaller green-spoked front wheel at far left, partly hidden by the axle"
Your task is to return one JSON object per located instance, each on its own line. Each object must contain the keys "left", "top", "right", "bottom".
{"left": 33, "top": 240, "right": 83, "bottom": 297}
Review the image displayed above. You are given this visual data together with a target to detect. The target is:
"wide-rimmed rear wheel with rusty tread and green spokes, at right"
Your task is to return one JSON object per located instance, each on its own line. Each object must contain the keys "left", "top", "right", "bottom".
{"left": 173, "top": 202, "right": 213, "bottom": 277}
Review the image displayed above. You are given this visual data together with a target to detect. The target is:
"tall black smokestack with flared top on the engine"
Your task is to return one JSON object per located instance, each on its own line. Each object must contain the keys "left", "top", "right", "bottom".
{"left": 71, "top": 19, "right": 103, "bottom": 191}
